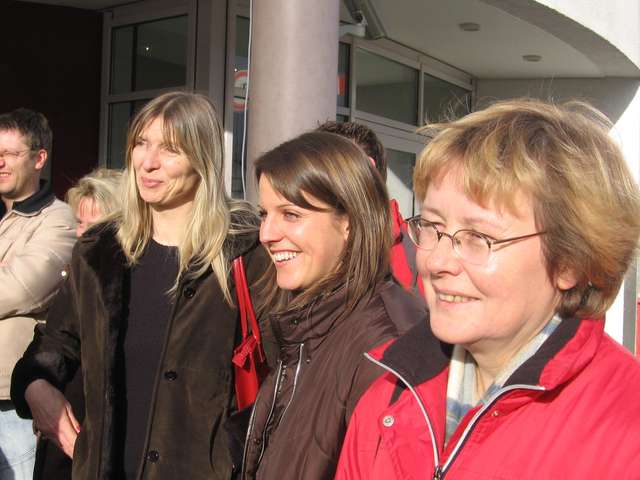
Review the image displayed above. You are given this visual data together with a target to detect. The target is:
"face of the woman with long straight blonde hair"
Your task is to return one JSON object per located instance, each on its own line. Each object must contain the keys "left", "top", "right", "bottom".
{"left": 131, "top": 117, "right": 200, "bottom": 210}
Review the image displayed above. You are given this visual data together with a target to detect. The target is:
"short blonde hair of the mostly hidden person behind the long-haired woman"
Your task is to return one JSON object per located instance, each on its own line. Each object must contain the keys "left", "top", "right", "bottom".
{"left": 65, "top": 168, "right": 122, "bottom": 217}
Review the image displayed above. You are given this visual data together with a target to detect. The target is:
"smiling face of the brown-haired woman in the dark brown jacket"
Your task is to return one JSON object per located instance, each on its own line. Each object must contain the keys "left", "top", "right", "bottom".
{"left": 259, "top": 175, "right": 349, "bottom": 290}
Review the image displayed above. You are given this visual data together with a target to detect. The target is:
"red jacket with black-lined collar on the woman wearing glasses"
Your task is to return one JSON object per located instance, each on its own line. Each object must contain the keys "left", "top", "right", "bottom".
{"left": 336, "top": 320, "right": 640, "bottom": 480}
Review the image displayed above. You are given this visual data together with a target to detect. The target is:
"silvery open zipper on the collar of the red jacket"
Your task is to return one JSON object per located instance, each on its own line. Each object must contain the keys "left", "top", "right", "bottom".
{"left": 364, "top": 353, "right": 546, "bottom": 480}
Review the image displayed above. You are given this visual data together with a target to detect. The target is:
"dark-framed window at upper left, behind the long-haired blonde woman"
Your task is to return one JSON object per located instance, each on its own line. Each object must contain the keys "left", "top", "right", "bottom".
{"left": 100, "top": 0, "right": 196, "bottom": 168}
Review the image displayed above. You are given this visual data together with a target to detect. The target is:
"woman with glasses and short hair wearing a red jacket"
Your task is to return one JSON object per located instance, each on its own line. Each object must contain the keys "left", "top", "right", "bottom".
{"left": 336, "top": 100, "right": 640, "bottom": 480}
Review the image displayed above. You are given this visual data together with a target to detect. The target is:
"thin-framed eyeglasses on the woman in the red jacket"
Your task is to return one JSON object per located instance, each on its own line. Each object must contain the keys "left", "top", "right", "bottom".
{"left": 406, "top": 215, "right": 546, "bottom": 265}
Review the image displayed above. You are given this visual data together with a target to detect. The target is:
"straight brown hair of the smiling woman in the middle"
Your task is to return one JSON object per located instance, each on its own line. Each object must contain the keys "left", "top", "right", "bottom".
{"left": 255, "top": 132, "right": 392, "bottom": 314}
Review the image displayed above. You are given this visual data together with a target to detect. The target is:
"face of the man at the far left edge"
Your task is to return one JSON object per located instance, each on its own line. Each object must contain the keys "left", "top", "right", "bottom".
{"left": 0, "top": 130, "right": 47, "bottom": 204}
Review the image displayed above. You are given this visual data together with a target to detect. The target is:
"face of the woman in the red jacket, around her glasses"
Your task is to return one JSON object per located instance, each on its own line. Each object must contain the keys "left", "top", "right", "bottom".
{"left": 417, "top": 171, "right": 575, "bottom": 361}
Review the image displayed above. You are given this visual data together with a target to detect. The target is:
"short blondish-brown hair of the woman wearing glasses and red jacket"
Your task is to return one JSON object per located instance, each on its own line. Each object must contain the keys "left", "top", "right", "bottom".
{"left": 413, "top": 99, "right": 640, "bottom": 318}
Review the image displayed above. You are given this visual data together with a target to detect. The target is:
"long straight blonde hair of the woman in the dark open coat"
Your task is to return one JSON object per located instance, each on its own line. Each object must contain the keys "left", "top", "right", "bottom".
{"left": 117, "top": 92, "right": 257, "bottom": 303}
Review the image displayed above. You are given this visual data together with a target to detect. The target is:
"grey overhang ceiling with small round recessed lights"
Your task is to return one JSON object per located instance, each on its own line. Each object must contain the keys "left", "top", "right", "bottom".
{"left": 372, "top": 0, "right": 602, "bottom": 78}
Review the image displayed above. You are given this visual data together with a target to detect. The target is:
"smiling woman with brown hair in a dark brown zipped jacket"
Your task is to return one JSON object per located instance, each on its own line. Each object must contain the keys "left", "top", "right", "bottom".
{"left": 243, "top": 132, "right": 426, "bottom": 480}
